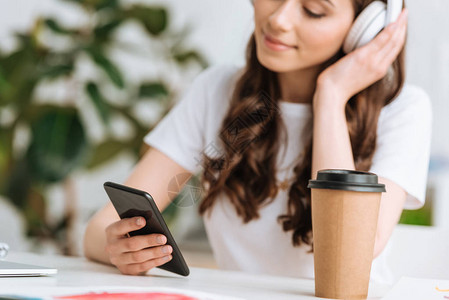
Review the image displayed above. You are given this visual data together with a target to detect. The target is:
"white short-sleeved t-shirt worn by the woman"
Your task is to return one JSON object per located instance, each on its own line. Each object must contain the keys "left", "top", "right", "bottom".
{"left": 144, "top": 65, "right": 431, "bottom": 283}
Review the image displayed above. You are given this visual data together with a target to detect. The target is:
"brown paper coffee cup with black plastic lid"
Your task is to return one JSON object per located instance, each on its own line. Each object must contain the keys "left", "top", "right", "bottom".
{"left": 308, "top": 170, "right": 385, "bottom": 299}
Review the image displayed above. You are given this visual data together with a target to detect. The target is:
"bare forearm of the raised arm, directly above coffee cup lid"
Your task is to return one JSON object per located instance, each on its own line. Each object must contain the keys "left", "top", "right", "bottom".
{"left": 312, "top": 88, "right": 355, "bottom": 179}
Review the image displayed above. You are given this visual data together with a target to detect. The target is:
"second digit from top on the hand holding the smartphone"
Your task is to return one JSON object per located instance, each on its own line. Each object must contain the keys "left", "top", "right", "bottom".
{"left": 107, "top": 234, "right": 167, "bottom": 253}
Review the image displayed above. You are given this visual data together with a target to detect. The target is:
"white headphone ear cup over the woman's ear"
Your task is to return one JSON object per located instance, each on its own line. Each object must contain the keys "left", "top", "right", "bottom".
{"left": 343, "top": 0, "right": 384, "bottom": 53}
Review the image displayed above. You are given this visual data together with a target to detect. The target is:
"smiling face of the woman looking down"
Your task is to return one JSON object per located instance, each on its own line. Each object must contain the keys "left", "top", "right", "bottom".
{"left": 254, "top": 0, "right": 354, "bottom": 72}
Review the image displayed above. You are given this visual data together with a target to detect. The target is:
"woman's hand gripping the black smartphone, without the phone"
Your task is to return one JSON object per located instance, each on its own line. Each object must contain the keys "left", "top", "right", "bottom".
{"left": 105, "top": 217, "right": 173, "bottom": 275}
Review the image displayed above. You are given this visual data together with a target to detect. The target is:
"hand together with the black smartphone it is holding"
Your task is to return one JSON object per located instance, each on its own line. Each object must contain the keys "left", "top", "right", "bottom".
{"left": 104, "top": 182, "right": 189, "bottom": 276}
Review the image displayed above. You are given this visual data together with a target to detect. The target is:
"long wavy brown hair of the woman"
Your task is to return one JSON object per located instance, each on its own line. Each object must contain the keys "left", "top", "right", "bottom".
{"left": 199, "top": 0, "right": 405, "bottom": 246}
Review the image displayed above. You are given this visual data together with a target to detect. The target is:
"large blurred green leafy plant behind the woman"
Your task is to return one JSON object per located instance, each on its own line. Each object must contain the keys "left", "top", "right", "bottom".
{"left": 0, "top": 0, "right": 207, "bottom": 254}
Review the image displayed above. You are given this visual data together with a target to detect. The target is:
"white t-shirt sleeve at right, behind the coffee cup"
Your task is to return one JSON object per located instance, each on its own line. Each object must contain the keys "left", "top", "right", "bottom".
{"left": 370, "top": 85, "right": 432, "bottom": 209}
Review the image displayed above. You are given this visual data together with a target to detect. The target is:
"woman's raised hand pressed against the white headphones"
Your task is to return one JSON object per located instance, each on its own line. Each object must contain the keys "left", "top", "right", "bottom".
{"left": 317, "top": 9, "right": 407, "bottom": 107}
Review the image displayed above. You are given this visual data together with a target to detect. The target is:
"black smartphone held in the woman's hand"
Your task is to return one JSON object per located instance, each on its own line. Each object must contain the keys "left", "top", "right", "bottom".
{"left": 103, "top": 182, "right": 190, "bottom": 276}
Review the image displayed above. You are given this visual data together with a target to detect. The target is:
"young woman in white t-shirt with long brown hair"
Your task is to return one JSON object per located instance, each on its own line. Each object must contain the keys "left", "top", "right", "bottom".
{"left": 85, "top": 0, "right": 431, "bottom": 281}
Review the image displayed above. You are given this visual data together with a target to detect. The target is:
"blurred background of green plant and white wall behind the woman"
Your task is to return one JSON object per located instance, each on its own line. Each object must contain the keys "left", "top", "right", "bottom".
{"left": 0, "top": 0, "right": 449, "bottom": 276}
